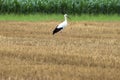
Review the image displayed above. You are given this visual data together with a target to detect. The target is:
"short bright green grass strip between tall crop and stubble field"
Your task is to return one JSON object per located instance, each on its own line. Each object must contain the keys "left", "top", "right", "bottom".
{"left": 0, "top": 14, "right": 120, "bottom": 21}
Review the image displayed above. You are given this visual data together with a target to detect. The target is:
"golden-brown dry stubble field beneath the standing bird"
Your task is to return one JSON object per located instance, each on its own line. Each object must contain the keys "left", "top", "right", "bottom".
{"left": 0, "top": 21, "right": 120, "bottom": 80}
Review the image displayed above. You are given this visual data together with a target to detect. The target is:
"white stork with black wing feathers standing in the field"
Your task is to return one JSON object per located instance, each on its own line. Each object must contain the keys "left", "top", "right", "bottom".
{"left": 53, "top": 14, "right": 69, "bottom": 35}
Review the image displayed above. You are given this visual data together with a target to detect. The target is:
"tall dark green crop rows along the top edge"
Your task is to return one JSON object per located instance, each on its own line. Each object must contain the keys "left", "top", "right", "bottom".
{"left": 0, "top": 0, "right": 120, "bottom": 14}
